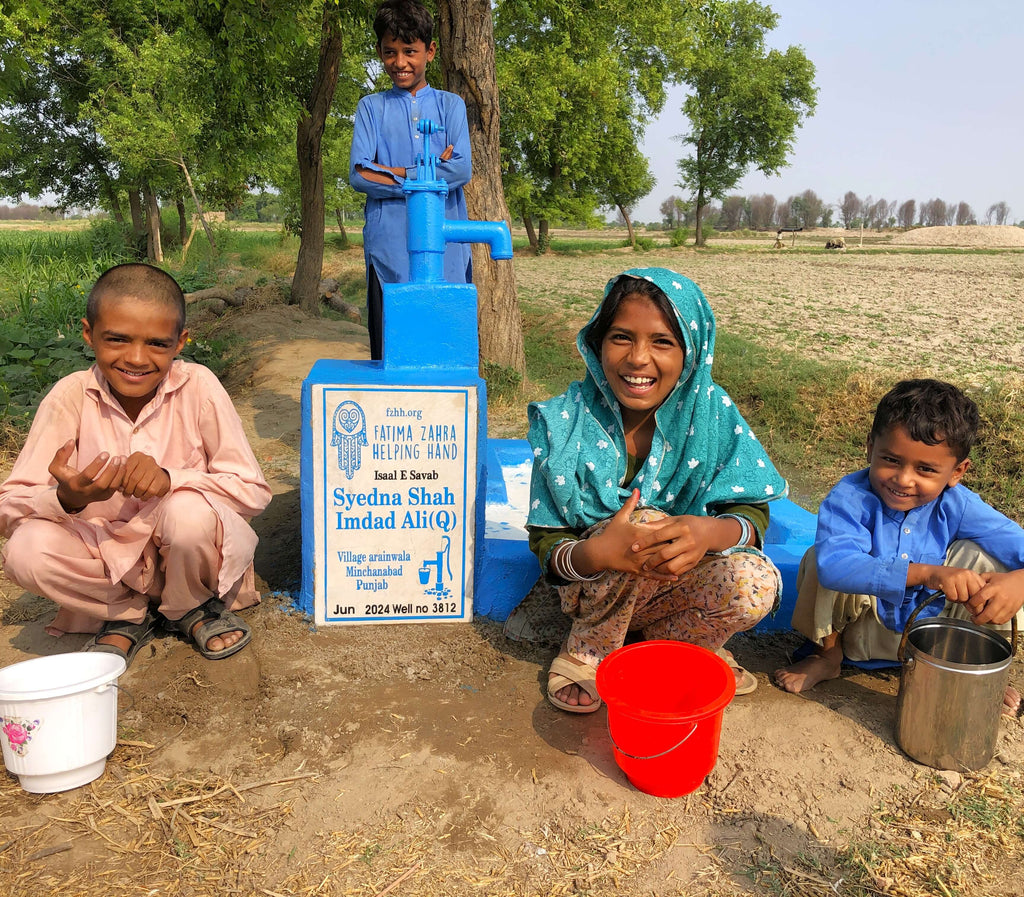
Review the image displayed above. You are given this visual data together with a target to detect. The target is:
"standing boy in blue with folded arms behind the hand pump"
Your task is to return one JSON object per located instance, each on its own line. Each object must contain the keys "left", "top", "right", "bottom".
{"left": 348, "top": 0, "right": 472, "bottom": 359}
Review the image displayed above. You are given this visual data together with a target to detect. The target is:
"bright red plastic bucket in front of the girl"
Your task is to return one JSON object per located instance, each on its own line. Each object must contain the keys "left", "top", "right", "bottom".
{"left": 597, "top": 641, "right": 736, "bottom": 798}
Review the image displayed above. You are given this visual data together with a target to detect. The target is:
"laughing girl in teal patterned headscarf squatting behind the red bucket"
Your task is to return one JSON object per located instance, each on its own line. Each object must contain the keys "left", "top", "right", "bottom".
{"left": 506, "top": 268, "right": 786, "bottom": 713}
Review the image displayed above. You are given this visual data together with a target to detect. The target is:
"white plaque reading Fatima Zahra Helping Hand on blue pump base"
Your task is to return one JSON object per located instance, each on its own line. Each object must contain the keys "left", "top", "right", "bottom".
{"left": 311, "top": 384, "right": 478, "bottom": 625}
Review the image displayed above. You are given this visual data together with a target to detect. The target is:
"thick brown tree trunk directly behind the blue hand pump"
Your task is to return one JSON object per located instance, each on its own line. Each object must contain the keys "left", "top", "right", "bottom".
{"left": 437, "top": 0, "right": 526, "bottom": 375}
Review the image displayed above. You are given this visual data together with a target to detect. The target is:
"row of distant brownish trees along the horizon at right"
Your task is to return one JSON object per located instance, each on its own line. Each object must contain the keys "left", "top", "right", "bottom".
{"left": 658, "top": 190, "right": 1013, "bottom": 230}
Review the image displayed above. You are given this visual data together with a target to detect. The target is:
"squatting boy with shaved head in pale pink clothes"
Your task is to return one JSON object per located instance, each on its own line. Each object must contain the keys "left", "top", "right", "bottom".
{"left": 0, "top": 264, "right": 270, "bottom": 663}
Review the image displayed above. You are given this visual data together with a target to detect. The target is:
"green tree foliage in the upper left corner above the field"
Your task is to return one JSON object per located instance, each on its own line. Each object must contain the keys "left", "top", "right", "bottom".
{"left": 0, "top": 0, "right": 305, "bottom": 222}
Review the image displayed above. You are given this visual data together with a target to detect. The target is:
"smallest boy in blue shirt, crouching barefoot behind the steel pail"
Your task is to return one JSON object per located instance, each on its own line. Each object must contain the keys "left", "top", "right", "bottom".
{"left": 775, "top": 380, "right": 1024, "bottom": 714}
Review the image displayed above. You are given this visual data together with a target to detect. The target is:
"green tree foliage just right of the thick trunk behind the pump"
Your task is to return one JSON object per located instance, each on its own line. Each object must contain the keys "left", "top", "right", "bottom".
{"left": 495, "top": 0, "right": 686, "bottom": 231}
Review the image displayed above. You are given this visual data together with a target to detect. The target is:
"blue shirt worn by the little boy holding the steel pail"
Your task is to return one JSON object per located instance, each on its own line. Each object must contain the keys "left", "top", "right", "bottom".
{"left": 814, "top": 468, "right": 1024, "bottom": 632}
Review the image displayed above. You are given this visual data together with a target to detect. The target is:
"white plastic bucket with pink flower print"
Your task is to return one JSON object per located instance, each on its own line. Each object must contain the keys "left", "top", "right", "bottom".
{"left": 0, "top": 651, "right": 127, "bottom": 794}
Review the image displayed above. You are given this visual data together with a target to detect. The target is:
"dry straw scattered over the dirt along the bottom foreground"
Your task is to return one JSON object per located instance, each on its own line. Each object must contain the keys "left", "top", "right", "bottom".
{"left": 0, "top": 740, "right": 1024, "bottom": 897}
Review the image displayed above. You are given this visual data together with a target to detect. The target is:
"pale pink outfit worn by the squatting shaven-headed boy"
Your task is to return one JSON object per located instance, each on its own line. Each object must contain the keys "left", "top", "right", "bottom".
{"left": 0, "top": 360, "right": 271, "bottom": 634}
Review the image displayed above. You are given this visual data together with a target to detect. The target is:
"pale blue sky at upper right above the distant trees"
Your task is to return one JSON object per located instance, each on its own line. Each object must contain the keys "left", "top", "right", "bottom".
{"left": 636, "top": 0, "right": 1024, "bottom": 222}
